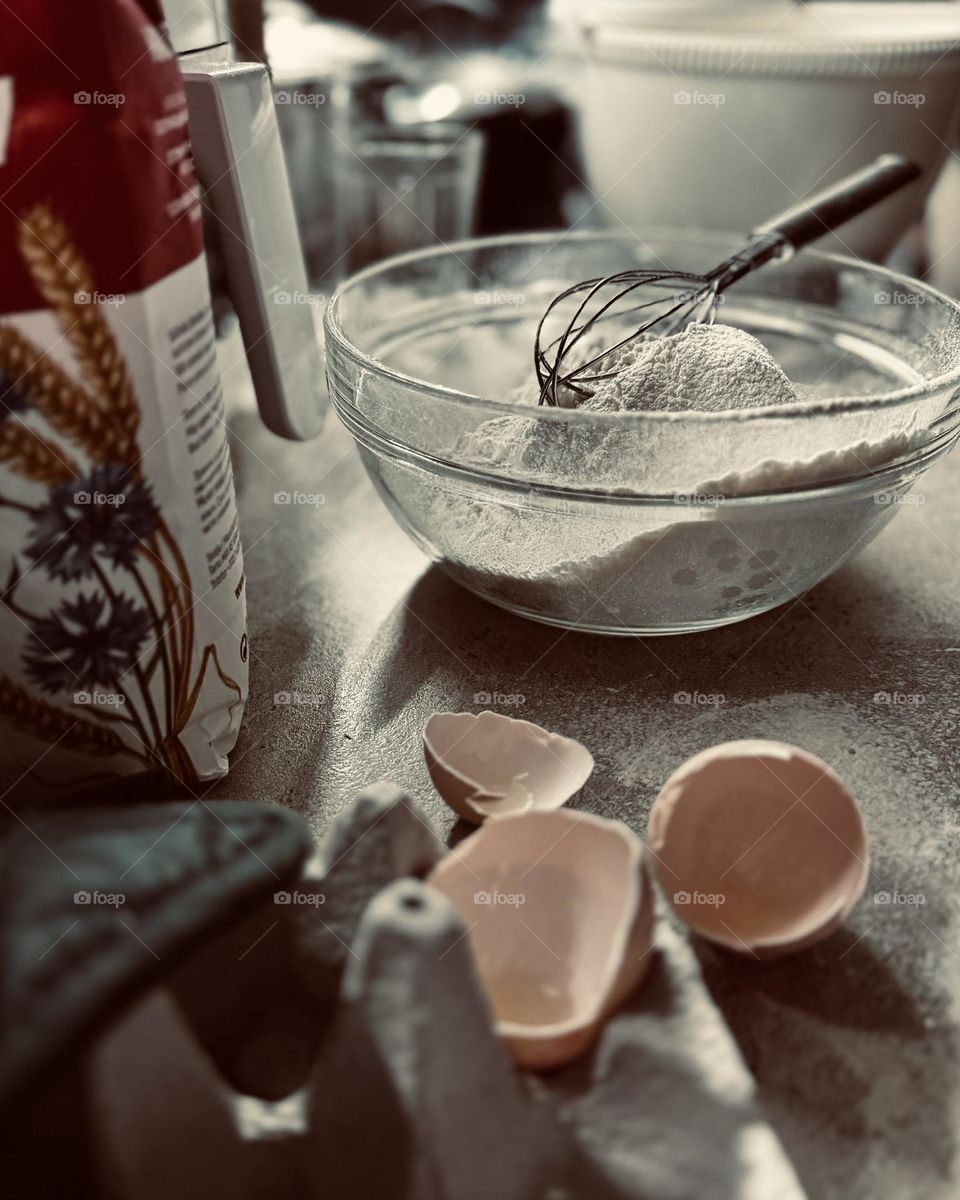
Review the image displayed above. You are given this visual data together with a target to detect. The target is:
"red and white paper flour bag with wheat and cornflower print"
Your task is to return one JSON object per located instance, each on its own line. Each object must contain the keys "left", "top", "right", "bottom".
{"left": 0, "top": 0, "right": 247, "bottom": 790}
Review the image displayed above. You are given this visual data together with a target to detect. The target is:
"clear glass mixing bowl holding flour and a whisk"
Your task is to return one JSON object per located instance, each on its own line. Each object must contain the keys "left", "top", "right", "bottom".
{"left": 325, "top": 230, "right": 960, "bottom": 634}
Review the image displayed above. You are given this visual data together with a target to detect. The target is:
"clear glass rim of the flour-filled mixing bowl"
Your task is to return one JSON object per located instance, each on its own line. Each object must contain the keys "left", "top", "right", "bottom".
{"left": 324, "top": 226, "right": 960, "bottom": 428}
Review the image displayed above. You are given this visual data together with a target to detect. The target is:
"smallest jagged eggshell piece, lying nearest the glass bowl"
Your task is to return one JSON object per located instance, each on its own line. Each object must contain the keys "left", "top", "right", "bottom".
{"left": 424, "top": 710, "right": 593, "bottom": 824}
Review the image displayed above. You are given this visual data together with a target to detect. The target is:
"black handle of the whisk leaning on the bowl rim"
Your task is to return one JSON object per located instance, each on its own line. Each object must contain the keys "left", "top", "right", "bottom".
{"left": 754, "top": 154, "right": 922, "bottom": 250}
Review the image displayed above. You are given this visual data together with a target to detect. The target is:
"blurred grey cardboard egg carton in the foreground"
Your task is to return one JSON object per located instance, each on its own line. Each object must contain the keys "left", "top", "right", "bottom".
{"left": 85, "top": 784, "right": 804, "bottom": 1200}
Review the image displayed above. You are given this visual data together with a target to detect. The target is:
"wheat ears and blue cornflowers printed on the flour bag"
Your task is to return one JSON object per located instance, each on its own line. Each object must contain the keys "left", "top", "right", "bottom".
{"left": 0, "top": 205, "right": 242, "bottom": 784}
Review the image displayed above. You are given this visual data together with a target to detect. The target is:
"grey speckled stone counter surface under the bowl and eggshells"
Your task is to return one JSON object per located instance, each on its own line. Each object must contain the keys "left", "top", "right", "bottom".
{"left": 215, "top": 386, "right": 960, "bottom": 1200}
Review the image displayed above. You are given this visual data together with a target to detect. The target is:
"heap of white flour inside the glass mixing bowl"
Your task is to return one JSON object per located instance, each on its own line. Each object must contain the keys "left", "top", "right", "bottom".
{"left": 415, "top": 325, "right": 913, "bottom": 625}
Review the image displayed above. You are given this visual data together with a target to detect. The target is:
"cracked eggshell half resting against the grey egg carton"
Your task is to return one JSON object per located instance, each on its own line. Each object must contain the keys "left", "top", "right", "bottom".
{"left": 427, "top": 809, "right": 653, "bottom": 1070}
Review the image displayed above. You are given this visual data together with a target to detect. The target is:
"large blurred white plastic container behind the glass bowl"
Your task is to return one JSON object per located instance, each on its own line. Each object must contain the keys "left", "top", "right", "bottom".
{"left": 553, "top": 0, "right": 960, "bottom": 259}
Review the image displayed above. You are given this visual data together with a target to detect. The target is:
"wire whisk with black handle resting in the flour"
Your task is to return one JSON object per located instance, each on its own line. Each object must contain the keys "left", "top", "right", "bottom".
{"left": 534, "top": 155, "right": 920, "bottom": 408}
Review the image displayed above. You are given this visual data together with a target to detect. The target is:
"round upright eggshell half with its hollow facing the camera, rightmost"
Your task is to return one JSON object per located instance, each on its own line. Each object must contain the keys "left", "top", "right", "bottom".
{"left": 647, "top": 740, "right": 869, "bottom": 958}
